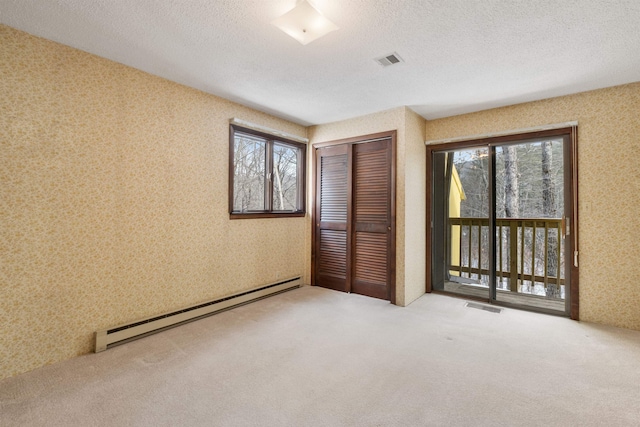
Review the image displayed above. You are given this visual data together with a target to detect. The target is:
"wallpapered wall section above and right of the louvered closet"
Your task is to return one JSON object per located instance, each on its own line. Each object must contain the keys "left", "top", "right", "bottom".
{"left": 309, "top": 107, "right": 426, "bottom": 306}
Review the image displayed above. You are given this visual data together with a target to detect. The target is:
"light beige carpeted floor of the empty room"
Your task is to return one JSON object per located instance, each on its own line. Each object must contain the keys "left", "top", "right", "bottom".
{"left": 0, "top": 287, "right": 640, "bottom": 427}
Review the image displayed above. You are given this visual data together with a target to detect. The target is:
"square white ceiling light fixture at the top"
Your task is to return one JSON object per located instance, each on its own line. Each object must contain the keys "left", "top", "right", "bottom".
{"left": 271, "top": 0, "right": 338, "bottom": 44}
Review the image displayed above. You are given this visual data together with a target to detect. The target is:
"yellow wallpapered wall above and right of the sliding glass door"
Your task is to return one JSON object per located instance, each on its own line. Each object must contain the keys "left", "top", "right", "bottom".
{"left": 426, "top": 83, "right": 640, "bottom": 330}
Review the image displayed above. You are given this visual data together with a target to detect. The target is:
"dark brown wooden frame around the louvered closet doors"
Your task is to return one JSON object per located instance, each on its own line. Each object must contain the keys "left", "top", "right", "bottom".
{"left": 309, "top": 130, "right": 398, "bottom": 305}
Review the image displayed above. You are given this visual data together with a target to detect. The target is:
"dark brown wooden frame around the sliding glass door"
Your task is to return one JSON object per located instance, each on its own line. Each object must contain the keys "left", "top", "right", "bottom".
{"left": 425, "top": 126, "right": 580, "bottom": 320}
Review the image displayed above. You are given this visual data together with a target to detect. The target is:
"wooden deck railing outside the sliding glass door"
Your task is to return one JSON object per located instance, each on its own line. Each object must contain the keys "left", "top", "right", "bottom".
{"left": 449, "top": 218, "right": 564, "bottom": 296}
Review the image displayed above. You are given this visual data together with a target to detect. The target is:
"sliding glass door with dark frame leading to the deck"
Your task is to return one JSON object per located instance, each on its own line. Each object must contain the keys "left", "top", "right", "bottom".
{"left": 428, "top": 128, "right": 577, "bottom": 317}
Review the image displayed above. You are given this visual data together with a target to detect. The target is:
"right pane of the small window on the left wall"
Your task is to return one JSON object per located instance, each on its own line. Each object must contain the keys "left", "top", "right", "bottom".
{"left": 273, "top": 143, "right": 298, "bottom": 211}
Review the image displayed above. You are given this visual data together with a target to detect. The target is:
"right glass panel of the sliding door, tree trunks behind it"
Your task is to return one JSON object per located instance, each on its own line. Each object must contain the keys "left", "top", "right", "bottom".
{"left": 495, "top": 137, "right": 566, "bottom": 312}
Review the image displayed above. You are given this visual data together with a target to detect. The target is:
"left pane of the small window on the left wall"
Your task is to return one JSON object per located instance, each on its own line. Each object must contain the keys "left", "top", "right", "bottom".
{"left": 233, "top": 132, "right": 266, "bottom": 212}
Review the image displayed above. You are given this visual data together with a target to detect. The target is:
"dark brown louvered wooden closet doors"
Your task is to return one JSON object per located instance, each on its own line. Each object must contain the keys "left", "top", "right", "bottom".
{"left": 313, "top": 132, "right": 395, "bottom": 302}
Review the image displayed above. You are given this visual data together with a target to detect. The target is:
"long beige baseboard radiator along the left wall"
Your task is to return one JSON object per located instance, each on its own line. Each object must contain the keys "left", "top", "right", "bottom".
{"left": 95, "top": 277, "right": 302, "bottom": 353}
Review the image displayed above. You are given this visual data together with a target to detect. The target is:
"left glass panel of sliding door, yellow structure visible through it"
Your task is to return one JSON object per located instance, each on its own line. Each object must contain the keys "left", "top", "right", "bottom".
{"left": 431, "top": 147, "right": 491, "bottom": 300}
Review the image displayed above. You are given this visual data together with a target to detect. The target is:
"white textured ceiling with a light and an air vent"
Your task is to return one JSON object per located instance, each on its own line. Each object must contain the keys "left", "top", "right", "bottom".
{"left": 0, "top": 0, "right": 640, "bottom": 125}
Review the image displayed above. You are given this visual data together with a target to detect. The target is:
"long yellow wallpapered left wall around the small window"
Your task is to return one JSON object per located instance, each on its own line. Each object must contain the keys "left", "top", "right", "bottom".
{"left": 0, "top": 26, "right": 308, "bottom": 378}
